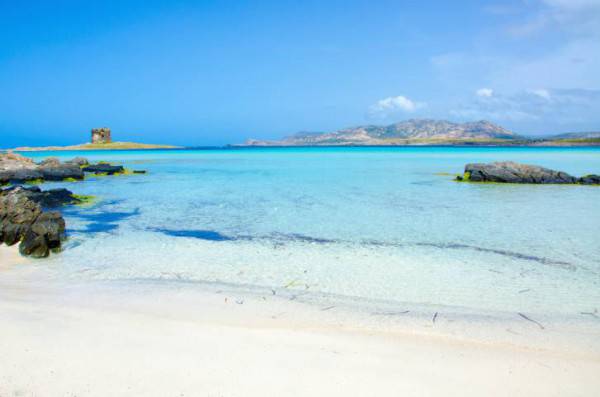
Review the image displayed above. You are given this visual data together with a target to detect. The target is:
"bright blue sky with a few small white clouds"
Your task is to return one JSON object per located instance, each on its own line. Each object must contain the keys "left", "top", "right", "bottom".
{"left": 0, "top": 0, "right": 600, "bottom": 147}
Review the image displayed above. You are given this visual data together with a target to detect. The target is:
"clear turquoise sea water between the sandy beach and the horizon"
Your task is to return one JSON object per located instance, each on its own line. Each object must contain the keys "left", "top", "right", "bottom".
{"left": 18, "top": 147, "right": 600, "bottom": 315}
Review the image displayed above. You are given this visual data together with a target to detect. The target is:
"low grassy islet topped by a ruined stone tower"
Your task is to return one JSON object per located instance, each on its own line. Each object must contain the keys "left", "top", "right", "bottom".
{"left": 12, "top": 127, "right": 180, "bottom": 152}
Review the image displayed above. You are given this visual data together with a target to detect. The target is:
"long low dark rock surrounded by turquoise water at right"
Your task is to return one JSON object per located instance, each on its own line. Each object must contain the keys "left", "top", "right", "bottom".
{"left": 457, "top": 161, "right": 600, "bottom": 184}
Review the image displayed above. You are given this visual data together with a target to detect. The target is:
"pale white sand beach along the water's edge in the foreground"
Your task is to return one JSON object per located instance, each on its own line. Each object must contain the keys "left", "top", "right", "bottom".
{"left": 0, "top": 247, "right": 600, "bottom": 397}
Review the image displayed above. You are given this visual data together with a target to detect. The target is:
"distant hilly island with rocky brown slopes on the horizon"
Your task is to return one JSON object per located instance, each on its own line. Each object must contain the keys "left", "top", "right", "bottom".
{"left": 236, "top": 119, "right": 600, "bottom": 146}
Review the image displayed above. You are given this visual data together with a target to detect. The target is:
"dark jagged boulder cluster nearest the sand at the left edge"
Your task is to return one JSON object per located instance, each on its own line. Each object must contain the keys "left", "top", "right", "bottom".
{"left": 0, "top": 188, "right": 65, "bottom": 258}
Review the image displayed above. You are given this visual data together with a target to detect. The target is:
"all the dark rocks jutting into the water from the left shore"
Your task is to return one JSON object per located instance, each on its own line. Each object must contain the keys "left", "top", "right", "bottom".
{"left": 0, "top": 153, "right": 144, "bottom": 258}
